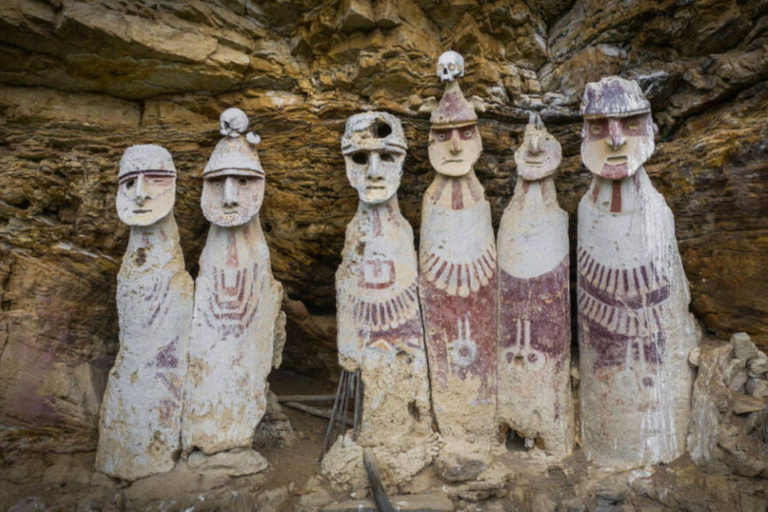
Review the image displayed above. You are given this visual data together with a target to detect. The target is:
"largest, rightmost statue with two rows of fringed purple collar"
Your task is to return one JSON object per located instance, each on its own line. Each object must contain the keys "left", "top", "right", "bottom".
{"left": 577, "top": 76, "right": 698, "bottom": 466}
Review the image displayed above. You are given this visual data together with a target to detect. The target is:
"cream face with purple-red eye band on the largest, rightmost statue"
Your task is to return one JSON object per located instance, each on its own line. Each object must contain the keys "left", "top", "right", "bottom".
{"left": 581, "top": 114, "right": 655, "bottom": 180}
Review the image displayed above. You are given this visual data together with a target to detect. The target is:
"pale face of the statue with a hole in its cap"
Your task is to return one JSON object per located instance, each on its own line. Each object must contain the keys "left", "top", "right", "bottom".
{"left": 344, "top": 149, "right": 405, "bottom": 204}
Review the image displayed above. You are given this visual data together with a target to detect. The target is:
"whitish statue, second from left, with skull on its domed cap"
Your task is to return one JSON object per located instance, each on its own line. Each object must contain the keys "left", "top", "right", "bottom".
{"left": 182, "top": 109, "right": 282, "bottom": 474}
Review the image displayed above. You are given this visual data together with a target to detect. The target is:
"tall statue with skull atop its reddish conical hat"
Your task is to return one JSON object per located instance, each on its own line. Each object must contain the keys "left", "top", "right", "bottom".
{"left": 419, "top": 51, "right": 497, "bottom": 480}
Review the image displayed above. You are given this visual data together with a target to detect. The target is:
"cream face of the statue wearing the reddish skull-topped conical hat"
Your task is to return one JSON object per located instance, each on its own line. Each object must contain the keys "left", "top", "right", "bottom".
{"left": 429, "top": 124, "right": 483, "bottom": 177}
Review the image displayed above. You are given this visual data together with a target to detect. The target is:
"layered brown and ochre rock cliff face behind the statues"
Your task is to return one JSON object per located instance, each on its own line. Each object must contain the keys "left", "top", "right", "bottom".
{"left": 0, "top": 0, "right": 768, "bottom": 450}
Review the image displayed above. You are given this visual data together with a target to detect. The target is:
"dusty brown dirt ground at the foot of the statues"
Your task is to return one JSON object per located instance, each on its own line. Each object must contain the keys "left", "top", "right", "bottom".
{"left": 0, "top": 372, "right": 768, "bottom": 512}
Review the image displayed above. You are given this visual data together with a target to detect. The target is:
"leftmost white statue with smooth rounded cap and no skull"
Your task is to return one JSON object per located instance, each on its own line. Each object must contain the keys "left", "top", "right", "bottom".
{"left": 96, "top": 144, "right": 193, "bottom": 480}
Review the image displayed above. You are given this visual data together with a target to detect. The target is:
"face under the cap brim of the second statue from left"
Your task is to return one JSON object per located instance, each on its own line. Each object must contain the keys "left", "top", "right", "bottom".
{"left": 200, "top": 172, "right": 264, "bottom": 227}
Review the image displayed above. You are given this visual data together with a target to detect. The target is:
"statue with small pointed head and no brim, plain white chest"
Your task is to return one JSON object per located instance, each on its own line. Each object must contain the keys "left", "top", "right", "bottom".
{"left": 498, "top": 114, "right": 573, "bottom": 456}
